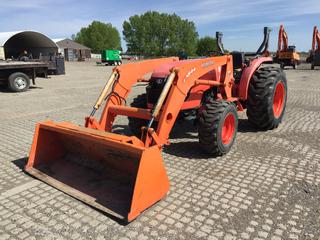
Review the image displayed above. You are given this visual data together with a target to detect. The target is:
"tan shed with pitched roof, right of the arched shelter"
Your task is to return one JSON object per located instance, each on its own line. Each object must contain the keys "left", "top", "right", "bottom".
{"left": 56, "top": 38, "right": 91, "bottom": 61}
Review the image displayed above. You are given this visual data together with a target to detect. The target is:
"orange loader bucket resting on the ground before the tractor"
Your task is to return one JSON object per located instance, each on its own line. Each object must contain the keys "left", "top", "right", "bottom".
{"left": 25, "top": 121, "right": 169, "bottom": 221}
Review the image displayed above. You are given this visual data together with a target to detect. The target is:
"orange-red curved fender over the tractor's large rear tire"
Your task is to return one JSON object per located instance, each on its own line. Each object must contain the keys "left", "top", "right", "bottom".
{"left": 239, "top": 57, "right": 272, "bottom": 100}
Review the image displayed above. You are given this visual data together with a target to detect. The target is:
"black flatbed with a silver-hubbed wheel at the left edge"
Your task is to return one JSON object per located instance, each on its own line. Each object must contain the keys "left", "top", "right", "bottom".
{"left": 0, "top": 61, "right": 49, "bottom": 92}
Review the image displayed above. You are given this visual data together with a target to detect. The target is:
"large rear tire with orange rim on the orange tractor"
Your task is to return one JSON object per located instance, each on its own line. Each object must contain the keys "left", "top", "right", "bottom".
{"left": 247, "top": 67, "right": 287, "bottom": 130}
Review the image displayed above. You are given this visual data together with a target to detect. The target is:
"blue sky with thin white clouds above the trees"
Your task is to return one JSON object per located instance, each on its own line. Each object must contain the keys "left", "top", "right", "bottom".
{"left": 0, "top": 0, "right": 320, "bottom": 51}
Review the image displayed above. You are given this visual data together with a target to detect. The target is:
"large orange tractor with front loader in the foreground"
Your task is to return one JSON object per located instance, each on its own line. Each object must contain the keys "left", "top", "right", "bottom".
{"left": 25, "top": 27, "right": 287, "bottom": 221}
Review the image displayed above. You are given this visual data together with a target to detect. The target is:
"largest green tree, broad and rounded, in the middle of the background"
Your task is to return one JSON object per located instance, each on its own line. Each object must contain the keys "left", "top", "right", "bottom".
{"left": 123, "top": 11, "right": 198, "bottom": 56}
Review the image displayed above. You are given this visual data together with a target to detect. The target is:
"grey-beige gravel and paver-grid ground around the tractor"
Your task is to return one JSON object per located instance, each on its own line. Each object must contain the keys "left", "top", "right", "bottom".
{"left": 0, "top": 62, "right": 320, "bottom": 240}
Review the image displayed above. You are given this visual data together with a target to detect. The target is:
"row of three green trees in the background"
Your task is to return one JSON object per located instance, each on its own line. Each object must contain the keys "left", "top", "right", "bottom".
{"left": 72, "top": 11, "right": 216, "bottom": 56}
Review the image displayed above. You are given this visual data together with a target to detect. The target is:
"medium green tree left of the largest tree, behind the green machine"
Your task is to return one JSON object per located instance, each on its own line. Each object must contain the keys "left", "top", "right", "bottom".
{"left": 75, "top": 21, "right": 121, "bottom": 53}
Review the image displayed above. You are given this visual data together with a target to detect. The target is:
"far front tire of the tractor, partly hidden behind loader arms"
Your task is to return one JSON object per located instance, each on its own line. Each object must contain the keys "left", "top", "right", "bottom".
{"left": 128, "top": 94, "right": 148, "bottom": 139}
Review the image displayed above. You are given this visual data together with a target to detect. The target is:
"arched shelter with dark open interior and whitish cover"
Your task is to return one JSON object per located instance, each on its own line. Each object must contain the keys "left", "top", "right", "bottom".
{"left": 0, "top": 31, "right": 58, "bottom": 59}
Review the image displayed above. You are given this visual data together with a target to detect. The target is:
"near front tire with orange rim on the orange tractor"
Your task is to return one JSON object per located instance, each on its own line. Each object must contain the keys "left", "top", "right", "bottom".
{"left": 198, "top": 99, "right": 238, "bottom": 156}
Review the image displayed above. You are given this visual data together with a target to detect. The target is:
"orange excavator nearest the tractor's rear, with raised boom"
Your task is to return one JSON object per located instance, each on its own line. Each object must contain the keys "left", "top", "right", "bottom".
{"left": 273, "top": 25, "right": 300, "bottom": 69}
